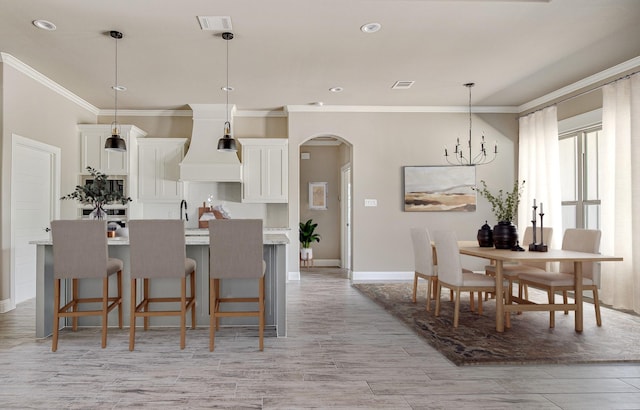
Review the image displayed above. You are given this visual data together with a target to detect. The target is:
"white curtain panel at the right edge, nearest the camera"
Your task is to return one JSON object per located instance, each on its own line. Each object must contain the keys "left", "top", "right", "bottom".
{"left": 598, "top": 74, "right": 640, "bottom": 313}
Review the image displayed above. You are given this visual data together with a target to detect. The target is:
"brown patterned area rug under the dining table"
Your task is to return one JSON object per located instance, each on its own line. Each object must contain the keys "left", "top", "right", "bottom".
{"left": 353, "top": 281, "right": 640, "bottom": 365}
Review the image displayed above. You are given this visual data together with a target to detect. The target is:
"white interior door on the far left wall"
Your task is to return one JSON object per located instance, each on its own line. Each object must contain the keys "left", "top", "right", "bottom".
{"left": 11, "top": 135, "right": 60, "bottom": 306}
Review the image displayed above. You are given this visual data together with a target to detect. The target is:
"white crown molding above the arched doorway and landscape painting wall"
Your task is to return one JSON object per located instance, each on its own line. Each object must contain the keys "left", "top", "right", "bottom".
{"left": 285, "top": 105, "right": 519, "bottom": 114}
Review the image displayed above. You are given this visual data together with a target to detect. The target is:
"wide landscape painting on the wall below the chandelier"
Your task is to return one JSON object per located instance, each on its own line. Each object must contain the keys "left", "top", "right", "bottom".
{"left": 403, "top": 166, "right": 476, "bottom": 212}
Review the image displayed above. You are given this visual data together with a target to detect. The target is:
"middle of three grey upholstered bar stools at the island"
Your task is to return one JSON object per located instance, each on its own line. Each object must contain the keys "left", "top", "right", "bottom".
{"left": 129, "top": 219, "right": 196, "bottom": 350}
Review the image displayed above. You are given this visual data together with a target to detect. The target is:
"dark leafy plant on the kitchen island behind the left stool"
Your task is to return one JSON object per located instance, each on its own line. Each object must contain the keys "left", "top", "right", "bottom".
{"left": 60, "top": 167, "right": 131, "bottom": 219}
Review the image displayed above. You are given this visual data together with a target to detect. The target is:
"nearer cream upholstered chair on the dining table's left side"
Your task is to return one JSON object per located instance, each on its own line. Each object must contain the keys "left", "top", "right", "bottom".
{"left": 434, "top": 231, "right": 496, "bottom": 327}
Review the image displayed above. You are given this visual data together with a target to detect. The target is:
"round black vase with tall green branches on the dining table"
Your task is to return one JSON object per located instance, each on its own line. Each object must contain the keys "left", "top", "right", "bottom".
{"left": 475, "top": 180, "right": 525, "bottom": 249}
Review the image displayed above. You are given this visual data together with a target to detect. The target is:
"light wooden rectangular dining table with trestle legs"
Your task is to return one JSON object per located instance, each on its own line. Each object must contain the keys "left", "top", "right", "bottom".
{"left": 459, "top": 246, "right": 622, "bottom": 332}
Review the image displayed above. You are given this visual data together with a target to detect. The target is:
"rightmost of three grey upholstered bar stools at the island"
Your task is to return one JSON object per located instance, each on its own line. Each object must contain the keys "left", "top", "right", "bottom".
{"left": 209, "top": 219, "right": 266, "bottom": 351}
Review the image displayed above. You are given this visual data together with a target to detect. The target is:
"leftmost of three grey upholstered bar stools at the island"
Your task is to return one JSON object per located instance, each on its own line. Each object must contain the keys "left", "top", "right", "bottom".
{"left": 51, "top": 220, "right": 122, "bottom": 352}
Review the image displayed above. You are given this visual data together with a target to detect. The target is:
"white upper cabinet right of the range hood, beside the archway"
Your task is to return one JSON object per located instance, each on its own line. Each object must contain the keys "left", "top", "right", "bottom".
{"left": 238, "top": 138, "right": 289, "bottom": 203}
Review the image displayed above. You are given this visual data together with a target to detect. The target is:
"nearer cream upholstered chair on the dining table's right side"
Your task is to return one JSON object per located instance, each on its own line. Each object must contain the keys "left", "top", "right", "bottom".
{"left": 519, "top": 229, "right": 602, "bottom": 327}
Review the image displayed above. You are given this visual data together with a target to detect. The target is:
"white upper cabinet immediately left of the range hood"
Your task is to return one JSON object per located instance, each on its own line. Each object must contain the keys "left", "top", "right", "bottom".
{"left": 138, "top": 138, "right": 187, "bottom": 202}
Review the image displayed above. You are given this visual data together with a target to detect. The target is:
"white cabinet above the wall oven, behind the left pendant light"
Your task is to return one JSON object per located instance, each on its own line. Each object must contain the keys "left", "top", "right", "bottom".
{"left": 78, "top": 124, "right": 147, "bottom": 175}
